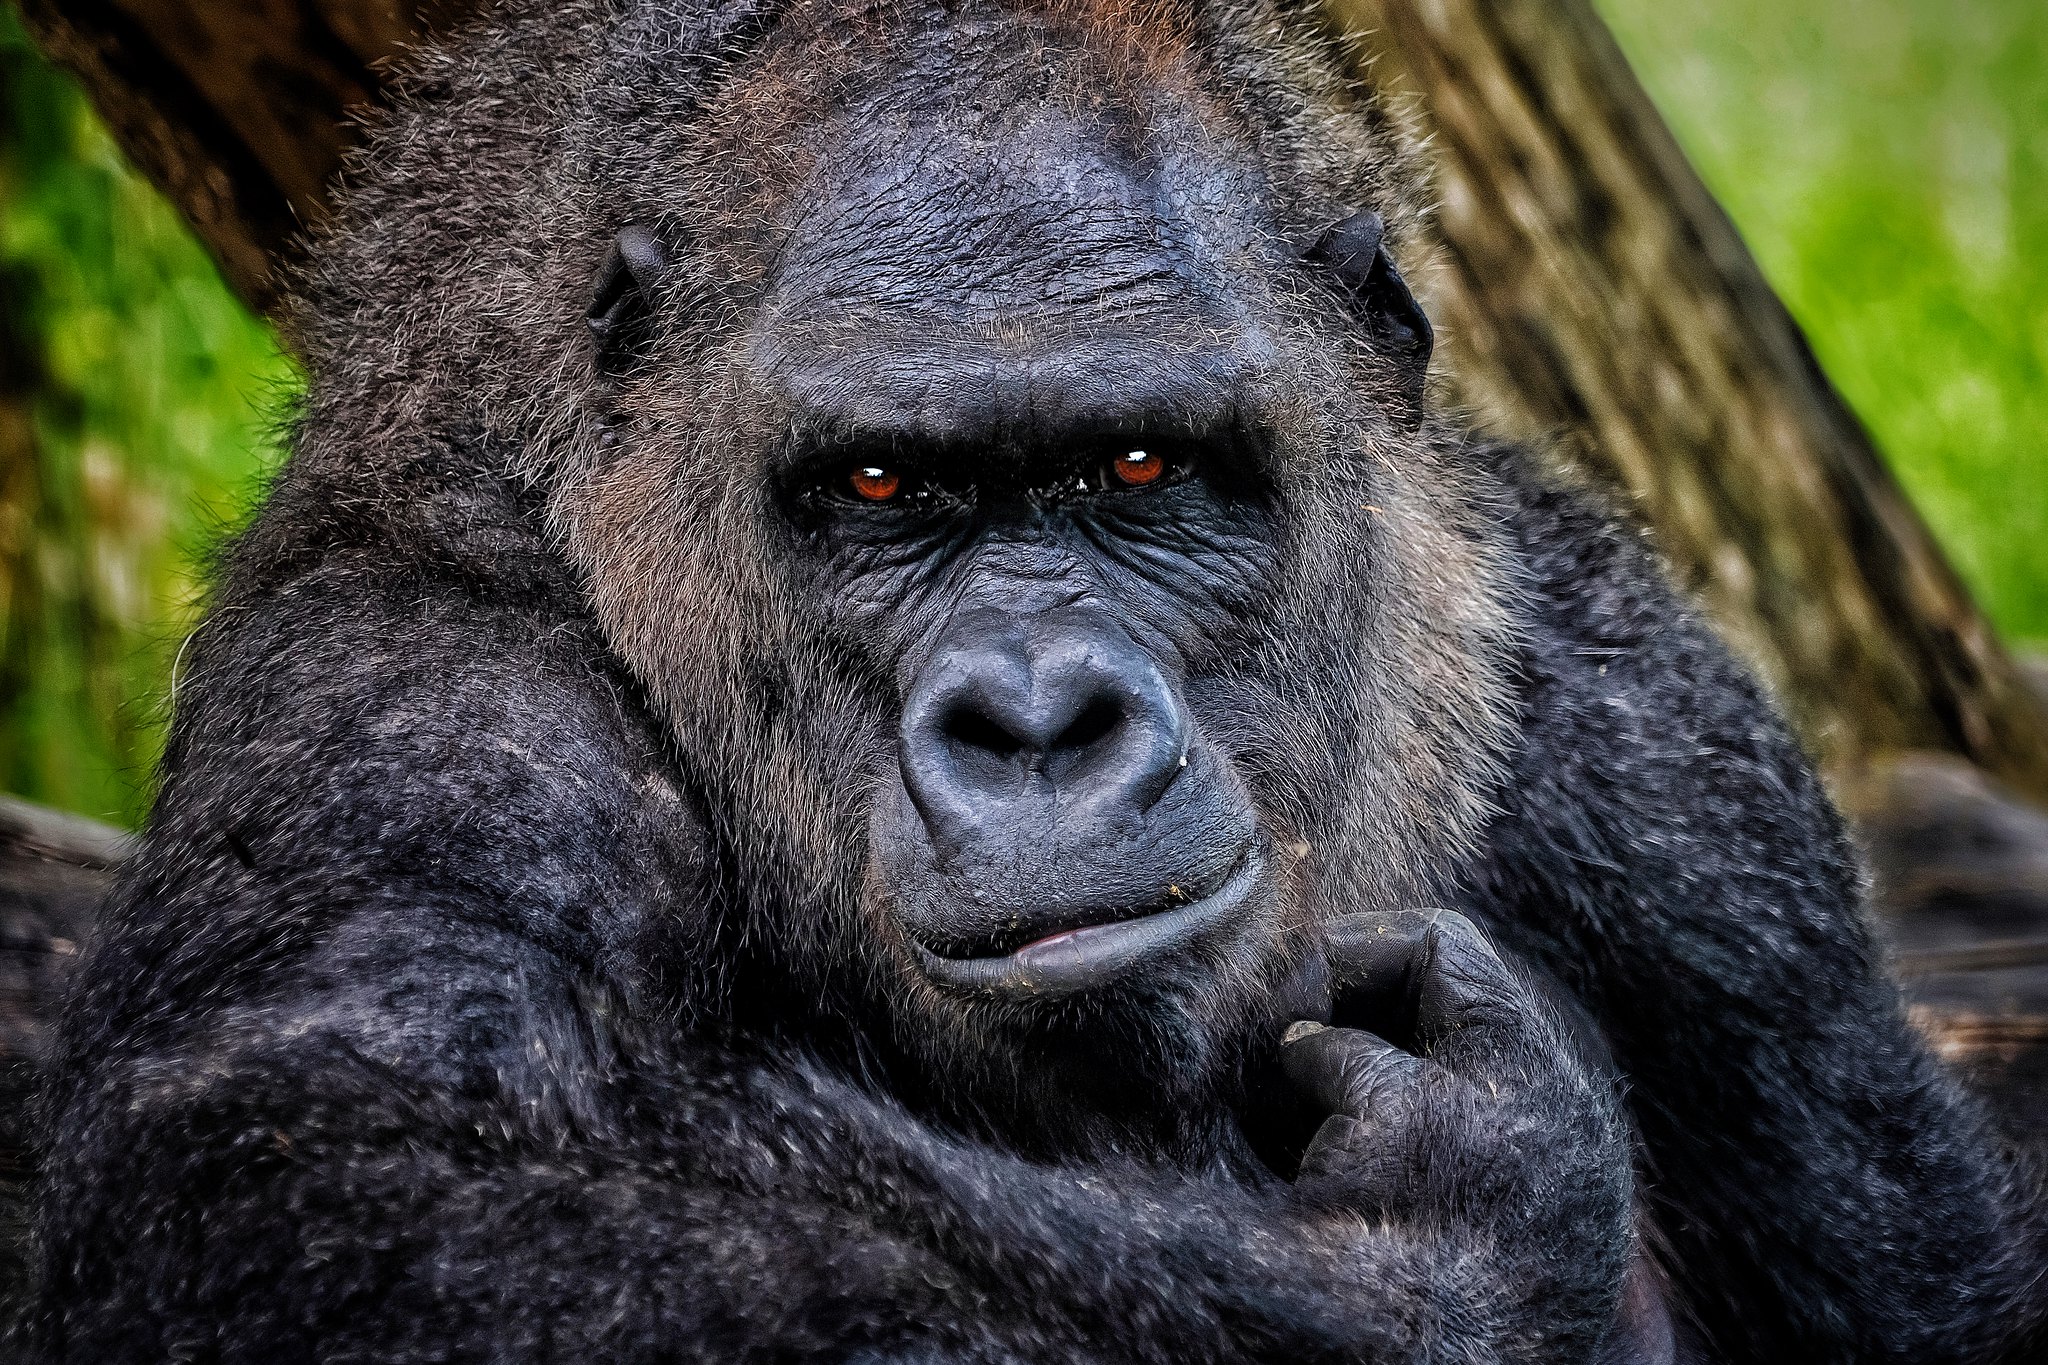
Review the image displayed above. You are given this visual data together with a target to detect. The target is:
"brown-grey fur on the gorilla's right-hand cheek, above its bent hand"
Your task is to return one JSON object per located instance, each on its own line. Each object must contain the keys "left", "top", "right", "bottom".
{"left": 1233, "top": 362, "right": 1516, "bottom": 933}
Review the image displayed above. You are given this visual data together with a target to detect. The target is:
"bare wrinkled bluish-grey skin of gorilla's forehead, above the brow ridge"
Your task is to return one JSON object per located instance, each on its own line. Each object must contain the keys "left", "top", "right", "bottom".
{"left": 768, "top": 102, "right": 1270, "bottom": 325}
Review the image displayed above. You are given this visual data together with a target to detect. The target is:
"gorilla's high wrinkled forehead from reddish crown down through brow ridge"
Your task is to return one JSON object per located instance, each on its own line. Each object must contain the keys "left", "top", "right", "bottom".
{"left": 758, "top": 5, "right": 1280, "bottom": 413}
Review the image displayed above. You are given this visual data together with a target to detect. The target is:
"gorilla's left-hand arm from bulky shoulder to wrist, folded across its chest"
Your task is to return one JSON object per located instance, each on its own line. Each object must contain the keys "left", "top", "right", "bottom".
{"left": 33, "top": 507, "right": 1626, "bottom": 1363}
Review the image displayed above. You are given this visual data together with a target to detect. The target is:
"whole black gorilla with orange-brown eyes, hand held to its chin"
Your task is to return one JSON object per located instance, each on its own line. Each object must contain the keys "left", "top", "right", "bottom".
{"left": 27, "top": 0, "right": 2048, "bottom": 1365}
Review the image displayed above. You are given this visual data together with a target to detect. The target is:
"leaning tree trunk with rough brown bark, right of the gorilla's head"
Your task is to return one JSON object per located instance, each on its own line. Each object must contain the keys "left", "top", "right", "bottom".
{"left": 1325, "top": 0, "right": 2048, "bottom": 798}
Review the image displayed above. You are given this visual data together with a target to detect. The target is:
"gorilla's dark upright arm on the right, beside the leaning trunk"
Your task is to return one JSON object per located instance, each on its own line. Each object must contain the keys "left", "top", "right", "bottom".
{"left": 1477, "top": 454, "right": 2048, "bottom": 1361}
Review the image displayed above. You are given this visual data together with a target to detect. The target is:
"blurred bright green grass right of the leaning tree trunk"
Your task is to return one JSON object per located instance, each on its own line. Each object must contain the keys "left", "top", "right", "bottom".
{"left": 1595, "top": 0, "right": 2048, "bottom": 643}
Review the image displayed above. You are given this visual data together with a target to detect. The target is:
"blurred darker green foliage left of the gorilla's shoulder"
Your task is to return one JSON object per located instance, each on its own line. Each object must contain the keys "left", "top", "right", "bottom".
{"left": 0, "top": 6, "right": 293, "bottom": 823}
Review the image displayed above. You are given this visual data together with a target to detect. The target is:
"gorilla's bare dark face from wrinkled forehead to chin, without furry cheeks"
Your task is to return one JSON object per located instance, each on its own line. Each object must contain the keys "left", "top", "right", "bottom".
{"left": 756, "top": 119, "right": 1282, "bottom": 999}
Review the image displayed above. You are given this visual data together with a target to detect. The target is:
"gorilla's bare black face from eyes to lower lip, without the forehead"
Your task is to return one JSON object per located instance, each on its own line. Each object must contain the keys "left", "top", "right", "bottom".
{"left": 797, "top": 388, "right": 1272, "bottom": 997}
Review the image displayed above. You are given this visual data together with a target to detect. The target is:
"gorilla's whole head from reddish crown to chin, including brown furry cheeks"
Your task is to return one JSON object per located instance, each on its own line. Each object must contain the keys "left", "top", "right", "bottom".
{"left": 557, "top": 6, "right": 1499, "bottom": 1129}
